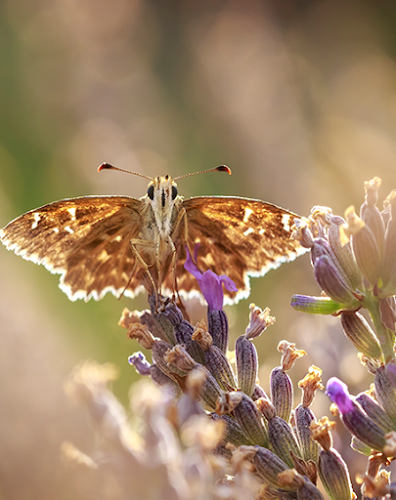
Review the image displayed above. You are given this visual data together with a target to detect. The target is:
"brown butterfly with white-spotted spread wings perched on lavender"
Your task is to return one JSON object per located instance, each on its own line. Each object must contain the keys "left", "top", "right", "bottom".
{"left": 0, "top": 163, "right": 305, "bottom": 303}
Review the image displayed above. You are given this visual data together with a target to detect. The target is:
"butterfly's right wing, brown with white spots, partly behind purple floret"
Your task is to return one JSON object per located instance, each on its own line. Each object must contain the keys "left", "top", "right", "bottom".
{"left": 166, "top": 196, "right": 306, "bottom": 303}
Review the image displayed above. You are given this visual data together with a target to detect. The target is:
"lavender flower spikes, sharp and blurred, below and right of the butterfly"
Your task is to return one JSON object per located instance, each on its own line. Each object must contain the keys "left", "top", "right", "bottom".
{"left": 64, "top": 178, "right": 396, "bottom": 500}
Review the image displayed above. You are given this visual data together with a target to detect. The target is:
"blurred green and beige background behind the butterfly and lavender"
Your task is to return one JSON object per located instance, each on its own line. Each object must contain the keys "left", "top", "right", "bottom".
{"left": 0, "top": 0, "right": 396, "bottom": 499}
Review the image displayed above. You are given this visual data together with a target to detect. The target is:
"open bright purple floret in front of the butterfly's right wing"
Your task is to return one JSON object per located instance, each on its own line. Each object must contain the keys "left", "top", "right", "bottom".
{"left": 184, "top": 245, "right": 238, "bottom": 311}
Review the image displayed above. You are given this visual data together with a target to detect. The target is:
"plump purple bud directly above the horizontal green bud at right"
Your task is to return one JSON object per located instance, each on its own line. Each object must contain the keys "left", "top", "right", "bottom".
{"left": 314, "top": 255, "right": 357, "bottom": 305}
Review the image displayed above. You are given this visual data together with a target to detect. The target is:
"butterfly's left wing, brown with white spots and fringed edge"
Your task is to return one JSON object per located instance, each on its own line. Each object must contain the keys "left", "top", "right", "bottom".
{"left": 0, "top": 196, "right": 143, "bottom": 301}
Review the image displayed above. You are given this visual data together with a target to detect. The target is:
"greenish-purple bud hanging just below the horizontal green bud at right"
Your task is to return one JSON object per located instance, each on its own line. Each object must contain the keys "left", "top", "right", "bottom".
{"left": 341, "top": 311, "right": 381, "bottom": 359}
